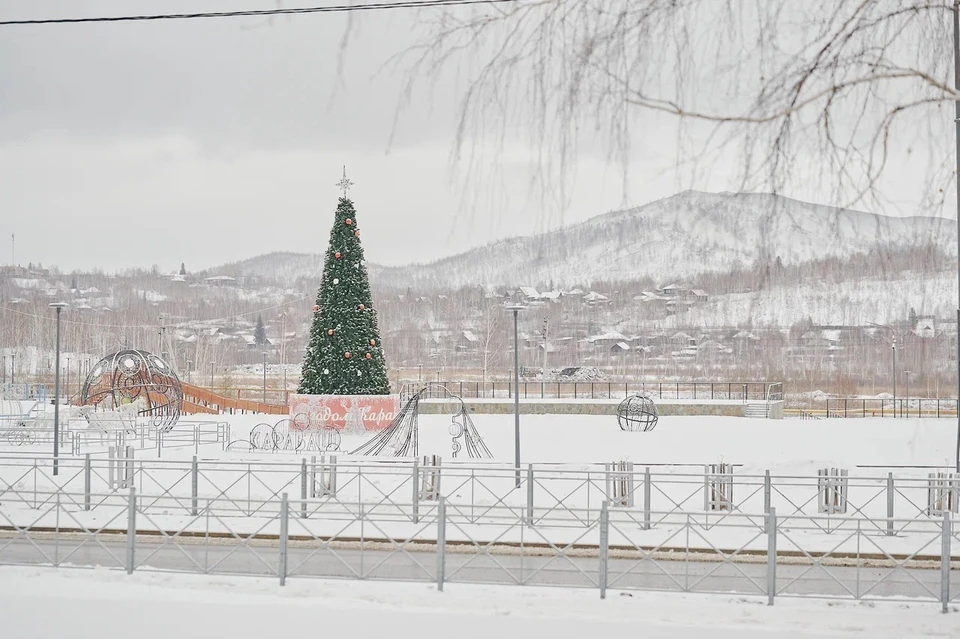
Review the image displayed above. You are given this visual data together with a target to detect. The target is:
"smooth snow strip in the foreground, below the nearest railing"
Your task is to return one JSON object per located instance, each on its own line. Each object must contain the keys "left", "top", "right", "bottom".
{"left": 0, "top": 567, "right": 960, "bottom": 639}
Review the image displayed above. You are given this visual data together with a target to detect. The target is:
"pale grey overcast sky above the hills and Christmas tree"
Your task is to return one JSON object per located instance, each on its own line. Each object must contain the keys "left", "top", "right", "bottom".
{"left": 0, "top": 0, "right": 953, "bottom": 270}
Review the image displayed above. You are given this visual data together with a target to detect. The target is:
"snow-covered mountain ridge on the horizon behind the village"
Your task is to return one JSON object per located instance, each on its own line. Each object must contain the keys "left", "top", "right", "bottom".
{"left": 209, "top": 191, "right": 957, "bottom": 290}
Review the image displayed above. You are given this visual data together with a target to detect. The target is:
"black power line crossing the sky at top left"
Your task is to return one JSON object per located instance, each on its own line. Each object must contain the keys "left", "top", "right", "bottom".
{"left": 0, "top": 0, "right": 517, "bottom": 26}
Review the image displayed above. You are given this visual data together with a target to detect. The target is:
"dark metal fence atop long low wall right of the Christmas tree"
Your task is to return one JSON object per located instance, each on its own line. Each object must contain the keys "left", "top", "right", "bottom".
{"left": 408, "top": 380, "right": 783, "bottom": 401}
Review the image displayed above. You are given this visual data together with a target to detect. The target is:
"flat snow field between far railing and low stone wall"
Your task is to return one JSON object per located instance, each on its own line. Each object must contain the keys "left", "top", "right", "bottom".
{"left": 223, "top": 415, "right": 957, "bottom": 468}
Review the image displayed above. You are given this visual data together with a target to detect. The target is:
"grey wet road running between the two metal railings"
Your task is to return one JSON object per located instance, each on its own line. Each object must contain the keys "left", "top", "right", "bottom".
{"left": 0, "top": 535, "right": 944, "bottom": 600}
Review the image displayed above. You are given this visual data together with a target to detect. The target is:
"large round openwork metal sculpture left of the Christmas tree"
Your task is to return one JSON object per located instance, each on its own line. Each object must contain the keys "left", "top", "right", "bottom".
{"left": 80, "top": 349, "right": 183, "bottom": 430}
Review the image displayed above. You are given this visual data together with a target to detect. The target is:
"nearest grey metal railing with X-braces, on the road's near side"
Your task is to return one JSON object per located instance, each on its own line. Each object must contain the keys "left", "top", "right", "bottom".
{"left": 0, "top": 486, "right": 960, "bottom": 611}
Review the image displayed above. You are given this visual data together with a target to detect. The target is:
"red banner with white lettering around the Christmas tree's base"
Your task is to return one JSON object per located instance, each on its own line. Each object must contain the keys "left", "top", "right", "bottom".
{"left": 288, "top": 395, "right": 400, "bottom": 432}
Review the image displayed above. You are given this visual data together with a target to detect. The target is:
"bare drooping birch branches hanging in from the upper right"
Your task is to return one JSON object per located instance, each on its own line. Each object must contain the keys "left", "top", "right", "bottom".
{"left": 400, "top": 0, "right": 958, "bottom": 215}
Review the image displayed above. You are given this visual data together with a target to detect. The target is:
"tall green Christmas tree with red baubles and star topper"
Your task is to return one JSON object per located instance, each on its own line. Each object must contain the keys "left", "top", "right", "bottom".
{"left": 297, "top": 170, "right": 390, "bottom": 395}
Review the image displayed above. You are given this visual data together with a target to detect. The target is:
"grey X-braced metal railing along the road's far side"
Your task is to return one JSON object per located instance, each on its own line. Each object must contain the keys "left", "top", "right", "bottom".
{"left": 0, "top": 456, "right": 960, "bottom": 528}
